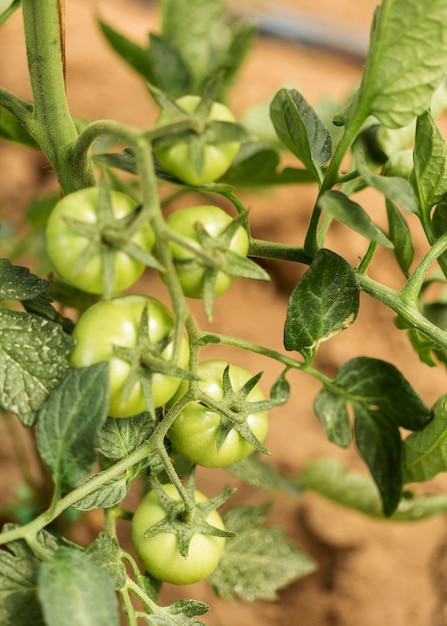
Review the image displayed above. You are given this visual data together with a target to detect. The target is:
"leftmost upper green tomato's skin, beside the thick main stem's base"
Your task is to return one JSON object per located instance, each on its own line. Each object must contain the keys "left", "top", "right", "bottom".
{"left": 46, "top": 187, "right": 155, "bottom": 294}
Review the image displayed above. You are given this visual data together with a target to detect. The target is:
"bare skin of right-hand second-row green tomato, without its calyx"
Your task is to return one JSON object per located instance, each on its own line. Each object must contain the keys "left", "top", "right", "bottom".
{"left": 166, "top": 206, "right": 249, "bottom": 298}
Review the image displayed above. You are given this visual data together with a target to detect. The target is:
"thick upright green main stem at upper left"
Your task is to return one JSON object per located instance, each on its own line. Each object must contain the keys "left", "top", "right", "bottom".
{"left": 22, "top": 0, "right": 93, "bottom": 193}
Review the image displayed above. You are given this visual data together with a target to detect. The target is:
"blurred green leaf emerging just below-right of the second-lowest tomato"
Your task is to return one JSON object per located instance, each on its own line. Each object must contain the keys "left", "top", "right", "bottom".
{"left": 226, "top": 454, "right": 301, "bottom": 496}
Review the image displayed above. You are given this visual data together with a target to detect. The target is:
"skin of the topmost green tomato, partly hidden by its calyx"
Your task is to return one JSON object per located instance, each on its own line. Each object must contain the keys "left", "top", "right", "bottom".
{"left": 155, "top": 96, "right": 240, "bottom": 185}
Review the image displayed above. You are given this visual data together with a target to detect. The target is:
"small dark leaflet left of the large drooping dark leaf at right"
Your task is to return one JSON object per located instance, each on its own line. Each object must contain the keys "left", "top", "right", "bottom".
{"left": 314, "top": 387, "right": 352, "bottom": 448}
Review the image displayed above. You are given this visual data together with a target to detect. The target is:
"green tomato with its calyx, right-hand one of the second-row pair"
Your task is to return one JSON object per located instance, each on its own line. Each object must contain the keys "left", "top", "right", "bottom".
{"left": 166, "top": 205, "right": 249, "bottom": 298}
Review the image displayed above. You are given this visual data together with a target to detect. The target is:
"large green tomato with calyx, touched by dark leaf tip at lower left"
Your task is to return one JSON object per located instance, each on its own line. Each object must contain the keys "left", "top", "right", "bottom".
{"left": 70, "top": 295, "right": 189, "bottom": 417}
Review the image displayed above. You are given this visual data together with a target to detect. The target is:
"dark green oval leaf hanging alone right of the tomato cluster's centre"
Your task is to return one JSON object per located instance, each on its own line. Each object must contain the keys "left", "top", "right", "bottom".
{"left": 284, "top": 250, "right": 360, "bottom": 360}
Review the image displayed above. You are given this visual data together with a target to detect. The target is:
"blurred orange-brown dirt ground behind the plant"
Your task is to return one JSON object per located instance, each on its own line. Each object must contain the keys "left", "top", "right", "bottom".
{"left": 0, "top": 0, "right": 447, "bottom": 626}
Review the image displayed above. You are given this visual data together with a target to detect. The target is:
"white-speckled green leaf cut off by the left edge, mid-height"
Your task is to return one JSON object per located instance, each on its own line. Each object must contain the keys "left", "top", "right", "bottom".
{"left": 0, "top": 310, "right": 73, "bottom": 426}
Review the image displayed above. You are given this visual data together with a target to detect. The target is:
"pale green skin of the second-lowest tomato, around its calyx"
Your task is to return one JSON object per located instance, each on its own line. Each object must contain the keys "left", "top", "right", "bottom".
{"left": 168, "top": 360, "right": 268, "bottom": 467}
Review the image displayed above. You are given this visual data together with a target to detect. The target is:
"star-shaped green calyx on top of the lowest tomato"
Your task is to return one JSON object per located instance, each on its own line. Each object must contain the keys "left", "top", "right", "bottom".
{"left": 144, "top": 472, "right": 236, "bottom": 558}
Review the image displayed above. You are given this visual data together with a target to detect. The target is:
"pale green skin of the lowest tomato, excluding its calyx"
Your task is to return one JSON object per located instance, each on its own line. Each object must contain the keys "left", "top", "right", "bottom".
{"left": 132, "top": 484, "right": 225, "bottom": 585}
